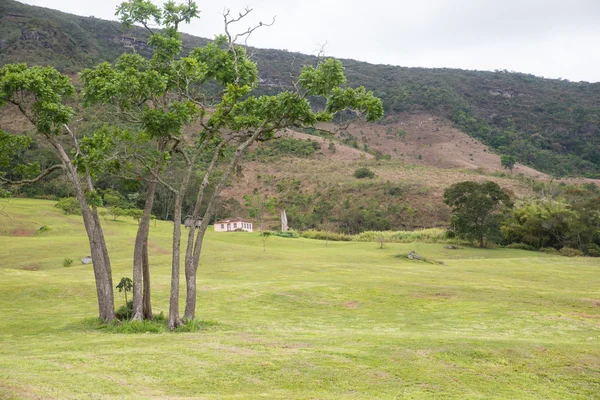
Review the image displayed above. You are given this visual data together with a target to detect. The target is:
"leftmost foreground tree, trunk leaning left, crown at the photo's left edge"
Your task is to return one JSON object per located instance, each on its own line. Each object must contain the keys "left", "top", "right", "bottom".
{"left": 0, "top": 64, "right": 115, "bottom": 322}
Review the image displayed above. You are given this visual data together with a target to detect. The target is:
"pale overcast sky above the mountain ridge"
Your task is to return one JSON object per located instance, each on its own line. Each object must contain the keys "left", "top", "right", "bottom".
{"left": 16, "top": 0, "right": 600, "bottom": 82}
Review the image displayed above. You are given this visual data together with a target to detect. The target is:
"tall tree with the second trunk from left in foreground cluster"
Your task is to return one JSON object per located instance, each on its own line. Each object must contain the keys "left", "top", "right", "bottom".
{"left": 81, "top": 0, "right": 203, "bottom": 320}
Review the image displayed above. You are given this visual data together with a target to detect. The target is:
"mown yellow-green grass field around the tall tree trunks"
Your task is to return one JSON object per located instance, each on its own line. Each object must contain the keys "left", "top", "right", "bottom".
{"left": 0, "top": 199, "right": 600, "bottom": 400}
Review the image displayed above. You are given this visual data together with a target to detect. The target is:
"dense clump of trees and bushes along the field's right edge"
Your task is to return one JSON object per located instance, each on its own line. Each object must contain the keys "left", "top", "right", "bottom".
{"left": 444, "top": 181, "right": 600, "bottom": 257}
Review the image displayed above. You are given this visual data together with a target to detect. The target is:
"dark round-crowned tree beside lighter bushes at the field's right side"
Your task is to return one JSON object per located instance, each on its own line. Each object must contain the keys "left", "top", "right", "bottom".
{"left": 444, "top": 181, "right": 512, "bottom": 247}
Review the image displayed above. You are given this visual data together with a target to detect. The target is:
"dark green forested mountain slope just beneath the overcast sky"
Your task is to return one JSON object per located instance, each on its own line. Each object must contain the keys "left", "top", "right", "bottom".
{"left": 0, "top": 0, "right": 600, "bottom": 177}
